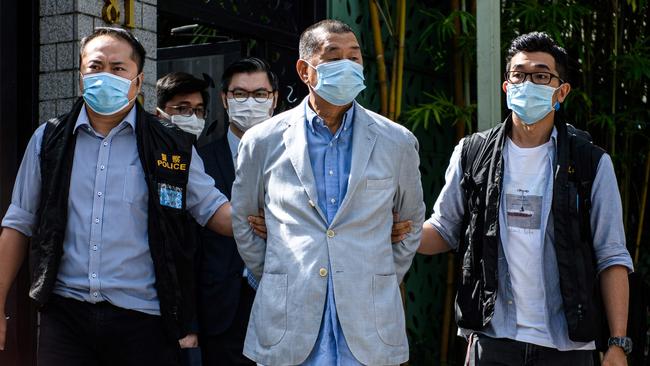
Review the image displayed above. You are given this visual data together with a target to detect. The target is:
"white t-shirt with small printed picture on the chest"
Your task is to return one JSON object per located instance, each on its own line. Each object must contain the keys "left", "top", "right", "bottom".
{"left": 499, "top": 138, "right": 553, "bottom": 347}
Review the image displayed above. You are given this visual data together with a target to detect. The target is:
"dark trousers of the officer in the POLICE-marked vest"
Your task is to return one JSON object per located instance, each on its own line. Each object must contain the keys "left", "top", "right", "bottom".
{"left": 38, "top": 295, "right": 180, "bottom": 366}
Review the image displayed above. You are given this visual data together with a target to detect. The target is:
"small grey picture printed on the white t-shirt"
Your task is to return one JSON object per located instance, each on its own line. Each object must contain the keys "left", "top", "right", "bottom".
{"left": 506, "top": 188, "right": 542, "bottom": 230}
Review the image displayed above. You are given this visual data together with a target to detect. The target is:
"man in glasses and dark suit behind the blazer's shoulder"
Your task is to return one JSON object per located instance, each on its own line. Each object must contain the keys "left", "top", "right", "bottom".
{"left": 198, "top": 57, "right": 278, "bottom": 366}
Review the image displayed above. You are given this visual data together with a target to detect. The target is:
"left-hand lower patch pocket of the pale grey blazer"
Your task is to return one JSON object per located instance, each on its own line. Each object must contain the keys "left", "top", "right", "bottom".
{"left": 253, "top": 273, "right": 288, "bottom": 347}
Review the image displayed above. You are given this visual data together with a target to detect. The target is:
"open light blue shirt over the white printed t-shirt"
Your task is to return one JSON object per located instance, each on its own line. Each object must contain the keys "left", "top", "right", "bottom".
{"left": 428, "top": 128, "right": 633, "bottom": 351}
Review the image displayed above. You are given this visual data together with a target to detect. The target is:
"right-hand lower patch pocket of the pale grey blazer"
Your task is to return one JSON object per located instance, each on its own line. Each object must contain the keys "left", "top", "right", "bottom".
{"left": 372, "top": 274, "right": 406, "bottom": 346}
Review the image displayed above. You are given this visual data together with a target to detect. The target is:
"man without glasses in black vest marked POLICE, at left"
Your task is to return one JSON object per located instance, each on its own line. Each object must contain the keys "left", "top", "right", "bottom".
{"left": 0, "top": 28, "right": 232, "bottom": 366}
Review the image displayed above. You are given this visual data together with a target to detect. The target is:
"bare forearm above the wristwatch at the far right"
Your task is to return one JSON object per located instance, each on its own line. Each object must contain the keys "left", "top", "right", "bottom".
{"left": 600, "top": 266, "right": 630, "bottom": 337}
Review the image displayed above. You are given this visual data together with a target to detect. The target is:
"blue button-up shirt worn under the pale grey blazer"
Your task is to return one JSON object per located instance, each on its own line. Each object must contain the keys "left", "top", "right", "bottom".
{"left": 303, "top": 103, "right": 361, "bottom": 366}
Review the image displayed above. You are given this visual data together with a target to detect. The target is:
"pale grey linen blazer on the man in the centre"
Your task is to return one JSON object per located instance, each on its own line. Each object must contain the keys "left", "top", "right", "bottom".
{"left": 232, "top": 99, "right": 425, "bottom": 366}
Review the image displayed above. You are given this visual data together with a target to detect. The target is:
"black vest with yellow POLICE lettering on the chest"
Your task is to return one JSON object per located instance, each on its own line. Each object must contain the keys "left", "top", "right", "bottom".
{"left": 30, "top": 98, "right": 196, "bottom": 339}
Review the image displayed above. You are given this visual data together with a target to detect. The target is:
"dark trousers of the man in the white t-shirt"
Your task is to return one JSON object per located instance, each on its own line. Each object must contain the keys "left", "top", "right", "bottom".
{"left": 466, "top": 334, "right": 593, "bottom": 366}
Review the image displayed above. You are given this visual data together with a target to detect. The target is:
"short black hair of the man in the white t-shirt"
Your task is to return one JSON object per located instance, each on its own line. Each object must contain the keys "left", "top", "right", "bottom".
{"left": 506, "top": 32, "right": 569, "bottom": 81}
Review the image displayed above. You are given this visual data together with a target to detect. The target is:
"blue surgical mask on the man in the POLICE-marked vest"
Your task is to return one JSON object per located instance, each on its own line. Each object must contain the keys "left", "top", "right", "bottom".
{"left": 83, "top": 72, "right": 137, "bottom": 116}
